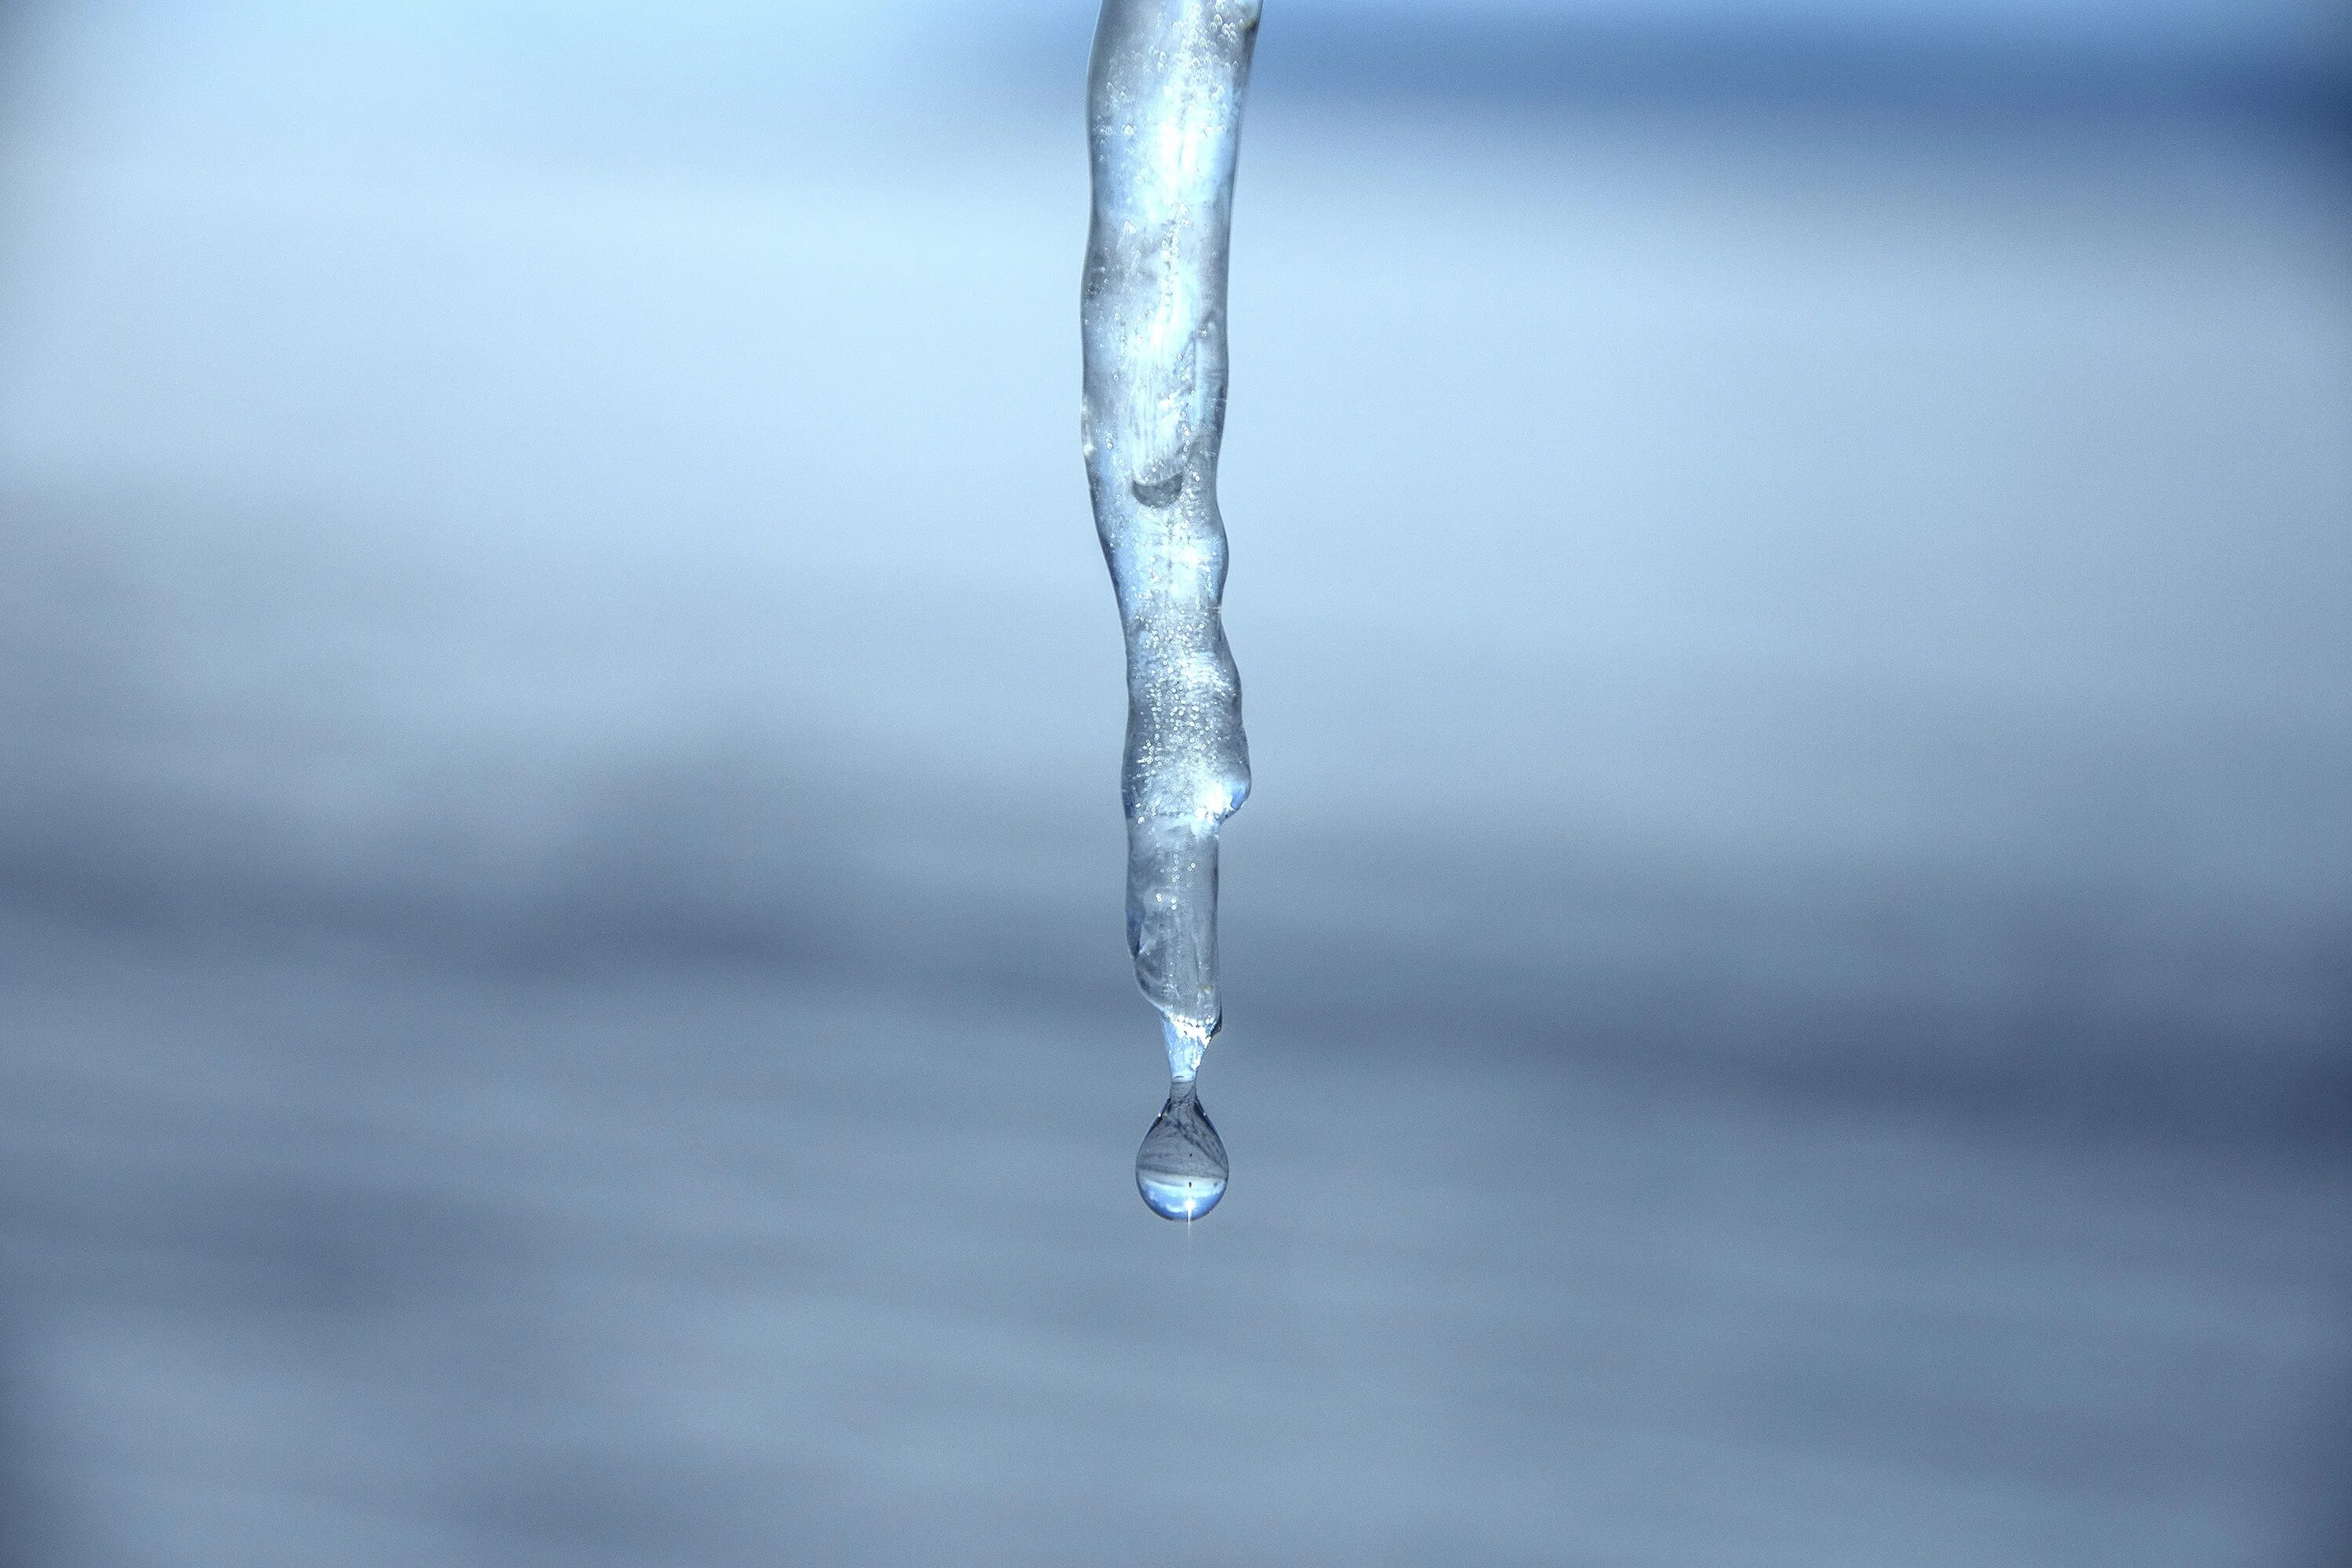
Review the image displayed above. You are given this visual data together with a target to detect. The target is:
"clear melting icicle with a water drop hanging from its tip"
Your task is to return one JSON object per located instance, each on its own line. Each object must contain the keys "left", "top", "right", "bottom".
{"left": 1080, "top": 0, "right": 1258, "bottom": 1220}
